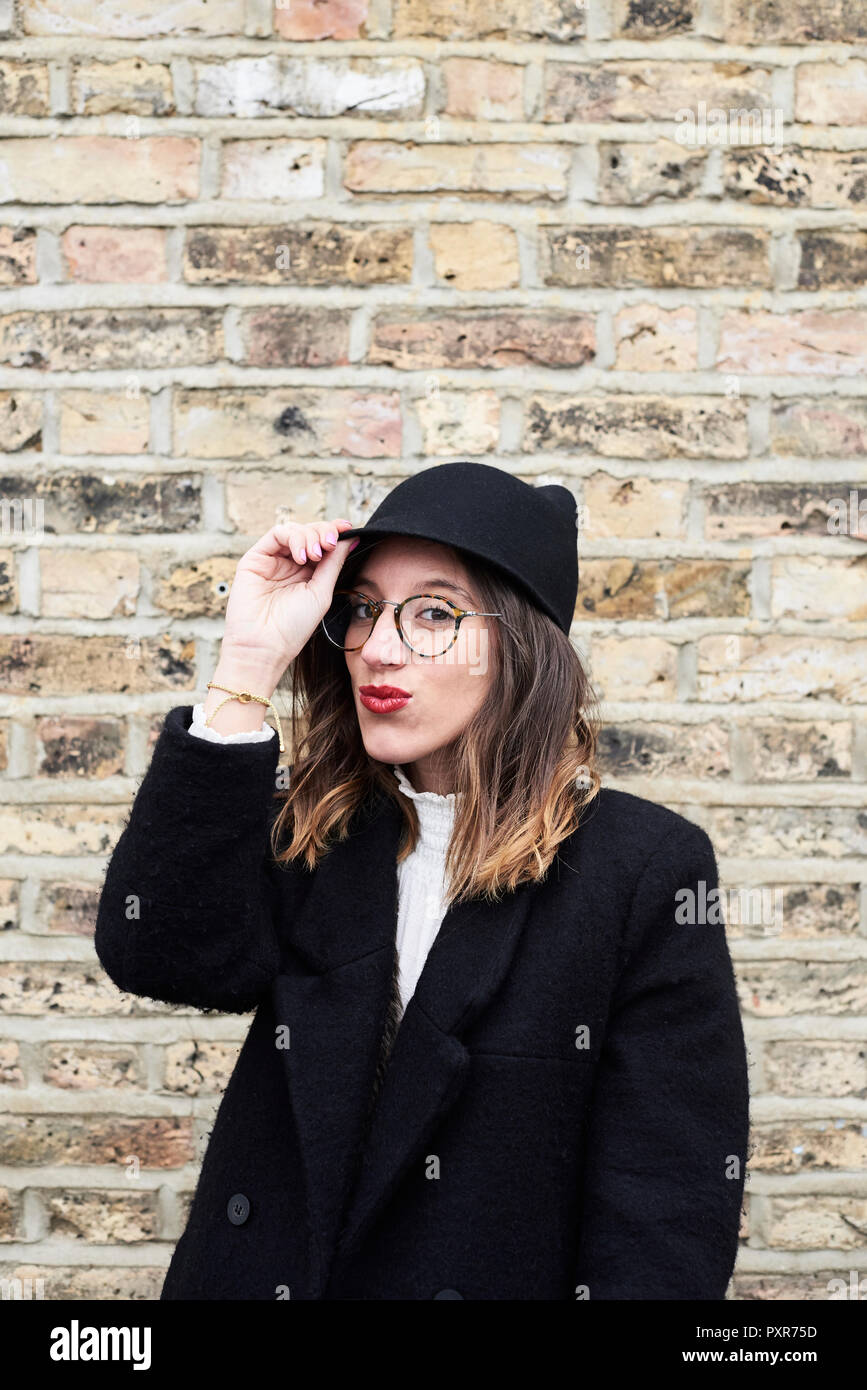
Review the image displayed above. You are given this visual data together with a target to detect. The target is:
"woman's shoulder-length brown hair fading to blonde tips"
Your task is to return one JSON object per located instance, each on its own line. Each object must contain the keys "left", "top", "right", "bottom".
{"left": 271, "top": 530, "right": 600, "bottom": 905}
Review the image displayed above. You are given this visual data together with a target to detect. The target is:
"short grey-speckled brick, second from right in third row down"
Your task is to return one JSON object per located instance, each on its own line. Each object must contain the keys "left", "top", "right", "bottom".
{"left": 596, "top": 140, "right": 707, "bottom": 207}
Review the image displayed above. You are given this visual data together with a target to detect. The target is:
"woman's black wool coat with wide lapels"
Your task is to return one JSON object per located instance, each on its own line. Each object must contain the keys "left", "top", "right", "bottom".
{"left": 96, "top": 705, "right": 749, "bottom": 1300}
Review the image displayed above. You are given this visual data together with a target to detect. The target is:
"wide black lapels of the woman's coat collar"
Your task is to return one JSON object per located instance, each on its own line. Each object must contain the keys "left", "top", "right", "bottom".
{"left": 274, "top": 791, "right": 536, "bottom": 1297}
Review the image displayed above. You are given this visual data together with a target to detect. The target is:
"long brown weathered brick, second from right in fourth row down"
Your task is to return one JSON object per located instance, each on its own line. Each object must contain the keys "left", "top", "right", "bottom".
{"left": 539, "top": 225, "right": 771, "bottom": 289}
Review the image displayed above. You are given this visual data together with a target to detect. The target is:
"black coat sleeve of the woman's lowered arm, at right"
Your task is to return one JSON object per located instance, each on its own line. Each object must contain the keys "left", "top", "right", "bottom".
{"left": 575, "top": 823, "right": 749, "bottom": 1300}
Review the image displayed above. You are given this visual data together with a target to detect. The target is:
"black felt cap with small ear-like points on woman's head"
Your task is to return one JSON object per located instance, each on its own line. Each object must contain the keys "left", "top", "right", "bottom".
{"left": 340, "top": 461, "right": 578, "bottom": 634}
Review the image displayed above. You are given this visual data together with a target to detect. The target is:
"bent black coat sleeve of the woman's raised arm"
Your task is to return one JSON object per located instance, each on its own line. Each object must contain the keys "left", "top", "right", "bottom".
{"left": 94, "top": 705, "right": 293, "bottom": 1013}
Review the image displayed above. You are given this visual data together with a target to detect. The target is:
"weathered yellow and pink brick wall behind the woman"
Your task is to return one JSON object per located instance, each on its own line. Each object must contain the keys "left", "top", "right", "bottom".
{"left": 0, "top": 0, "right": 867, "bottom": 1298}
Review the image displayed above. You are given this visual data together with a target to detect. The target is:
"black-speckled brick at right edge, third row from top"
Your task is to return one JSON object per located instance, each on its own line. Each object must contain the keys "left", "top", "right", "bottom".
{"left": 723, "top": 145, "right": 867, "bottom": 209}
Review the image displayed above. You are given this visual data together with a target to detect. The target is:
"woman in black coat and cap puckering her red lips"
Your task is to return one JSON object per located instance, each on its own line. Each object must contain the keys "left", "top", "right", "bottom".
{"left": 96, "top": 463, "right": 748, "bottom": 1300}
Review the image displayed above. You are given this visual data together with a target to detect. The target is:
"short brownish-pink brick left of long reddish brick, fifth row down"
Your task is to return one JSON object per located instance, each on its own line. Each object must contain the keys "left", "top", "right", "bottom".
{"left": 240, "top": 304, "right": 352, "bottom": 367}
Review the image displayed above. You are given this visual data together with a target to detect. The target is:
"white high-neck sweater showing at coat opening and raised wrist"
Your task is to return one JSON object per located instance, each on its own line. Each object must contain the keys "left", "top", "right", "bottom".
{"left": 189, "top": 703, "right": 457, "bottom": 1009}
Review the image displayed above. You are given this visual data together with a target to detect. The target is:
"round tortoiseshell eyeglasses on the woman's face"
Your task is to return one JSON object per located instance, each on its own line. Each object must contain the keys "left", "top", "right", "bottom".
{"left": 322, "top": 589, "right": 503, "bottom": 656}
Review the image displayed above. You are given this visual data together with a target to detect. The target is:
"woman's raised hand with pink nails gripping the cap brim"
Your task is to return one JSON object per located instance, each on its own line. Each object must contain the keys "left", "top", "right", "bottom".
{"left": 221, "top": 517, "right": 356, "bottom": 669}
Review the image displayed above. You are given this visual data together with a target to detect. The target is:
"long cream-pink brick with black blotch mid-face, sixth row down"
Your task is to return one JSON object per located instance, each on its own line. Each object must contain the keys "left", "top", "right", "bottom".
{"left": 174, "top": 386, "right": 400, "bottom": 459}
